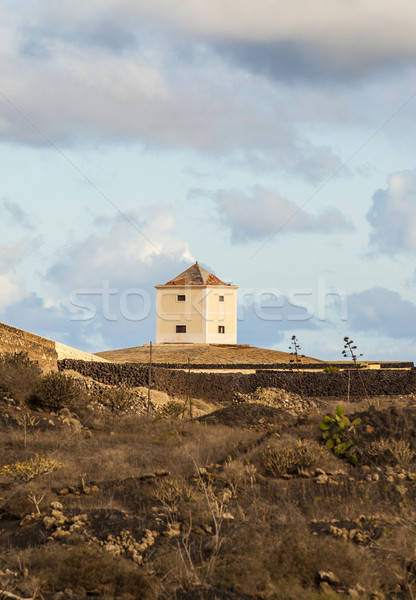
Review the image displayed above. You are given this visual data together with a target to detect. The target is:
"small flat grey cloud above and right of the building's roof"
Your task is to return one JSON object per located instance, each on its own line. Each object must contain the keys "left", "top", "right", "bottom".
{"left": 215, "top": 186, "right": 353, "bottom": 242}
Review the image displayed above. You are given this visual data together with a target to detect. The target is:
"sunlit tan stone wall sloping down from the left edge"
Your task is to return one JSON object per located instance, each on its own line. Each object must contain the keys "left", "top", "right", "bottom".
{"left": 0, "top": 323, "right": 58, "bottom": 371}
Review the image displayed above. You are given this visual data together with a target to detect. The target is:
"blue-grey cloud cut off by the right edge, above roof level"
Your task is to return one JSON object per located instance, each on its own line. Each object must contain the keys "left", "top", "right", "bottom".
{"left": 367, "top": 171, "right": 416, "bottom": 256}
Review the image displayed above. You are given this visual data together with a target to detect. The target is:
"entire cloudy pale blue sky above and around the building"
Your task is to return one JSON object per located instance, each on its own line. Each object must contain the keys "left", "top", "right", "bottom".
{"left": 0, "top": 0, "right": 416, "bottom": 361}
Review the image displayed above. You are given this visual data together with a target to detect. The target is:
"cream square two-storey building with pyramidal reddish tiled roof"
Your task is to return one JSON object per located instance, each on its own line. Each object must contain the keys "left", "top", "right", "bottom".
{"left": 155, "top": 262, "right": 238, "bottom": 344}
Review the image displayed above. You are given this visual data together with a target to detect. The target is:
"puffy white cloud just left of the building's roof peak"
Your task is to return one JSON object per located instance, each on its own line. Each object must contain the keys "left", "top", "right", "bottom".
{"left": 48, "top": 205, "right": 193, "bottom": 292}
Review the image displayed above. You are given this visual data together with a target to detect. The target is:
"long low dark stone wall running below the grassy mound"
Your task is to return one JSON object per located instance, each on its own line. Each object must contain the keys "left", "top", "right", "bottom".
{"left": 58, "top": 359, "right": 416, "bottom": 402}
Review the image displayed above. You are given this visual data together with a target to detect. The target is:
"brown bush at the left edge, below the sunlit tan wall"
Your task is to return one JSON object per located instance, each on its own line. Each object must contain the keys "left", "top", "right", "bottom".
{"left": 0, "top": 352, "right": 42, "bottom": 403}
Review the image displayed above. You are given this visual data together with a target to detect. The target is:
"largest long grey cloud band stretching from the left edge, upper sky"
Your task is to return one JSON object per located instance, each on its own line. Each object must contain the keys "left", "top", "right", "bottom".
{"left": 0, "top": 27, "right": 340, "bottom": 178}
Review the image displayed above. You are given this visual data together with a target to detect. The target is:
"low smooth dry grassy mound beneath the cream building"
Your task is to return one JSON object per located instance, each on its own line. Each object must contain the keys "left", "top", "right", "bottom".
{"left": 97, "top": 344, "right": 322, "bottom": 365}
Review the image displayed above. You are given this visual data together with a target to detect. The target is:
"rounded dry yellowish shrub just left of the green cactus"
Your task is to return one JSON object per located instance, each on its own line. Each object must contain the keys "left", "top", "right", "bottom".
{"left": 261, "top": 442, "right": 326, "bottom": 477}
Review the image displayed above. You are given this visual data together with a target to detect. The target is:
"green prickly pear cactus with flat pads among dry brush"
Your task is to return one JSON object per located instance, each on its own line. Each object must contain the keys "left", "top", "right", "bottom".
{"left": 320, "top": 404, "right": 361, "bottom": 465}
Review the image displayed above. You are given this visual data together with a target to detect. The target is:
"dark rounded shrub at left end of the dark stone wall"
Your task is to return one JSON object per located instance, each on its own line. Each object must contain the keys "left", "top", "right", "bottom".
{"left": 30, "top": 372, "right": 85, "bottom": 410}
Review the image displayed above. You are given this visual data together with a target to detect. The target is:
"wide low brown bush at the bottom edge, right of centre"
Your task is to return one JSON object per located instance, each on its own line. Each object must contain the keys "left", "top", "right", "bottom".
{"left": 212, "top": 522, "right": 377, "bottom": 600}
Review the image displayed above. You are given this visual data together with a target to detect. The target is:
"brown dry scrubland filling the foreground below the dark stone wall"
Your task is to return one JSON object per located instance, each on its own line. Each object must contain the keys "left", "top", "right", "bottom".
{"left": 0, "top": 358, "right": 416, "bottom": 600}
